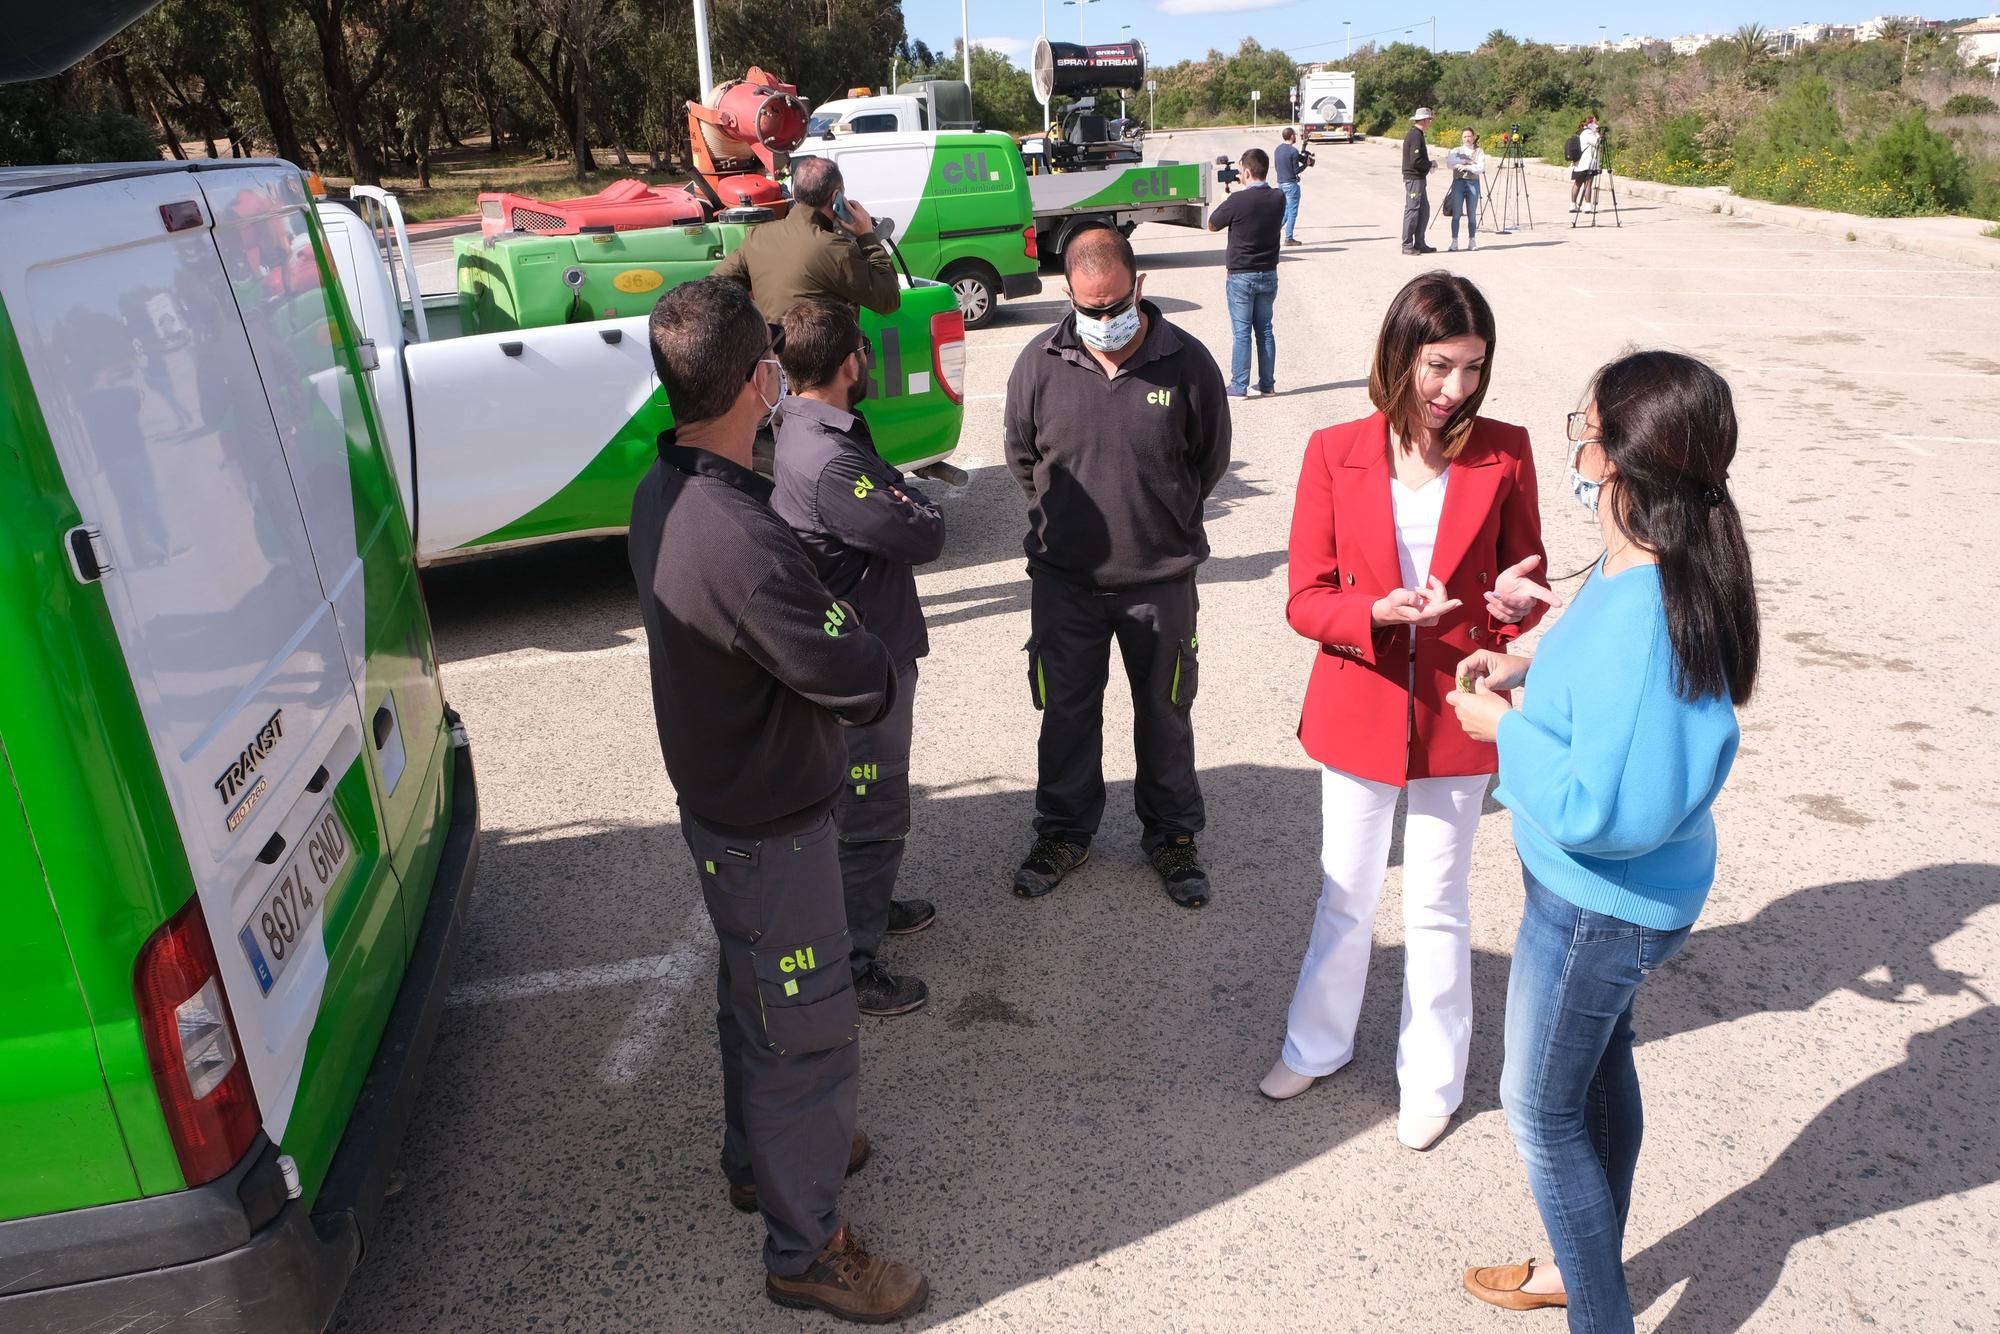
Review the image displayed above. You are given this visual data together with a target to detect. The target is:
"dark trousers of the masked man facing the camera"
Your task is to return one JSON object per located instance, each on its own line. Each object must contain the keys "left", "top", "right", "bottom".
{"left": 1028, "top": 570, "right": 1204, "bottom": 854}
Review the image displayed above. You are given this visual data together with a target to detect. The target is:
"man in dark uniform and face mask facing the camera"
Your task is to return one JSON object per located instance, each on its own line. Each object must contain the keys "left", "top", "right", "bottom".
{"left": 1002, "top": 228, "right": 1230, "bottom": 908}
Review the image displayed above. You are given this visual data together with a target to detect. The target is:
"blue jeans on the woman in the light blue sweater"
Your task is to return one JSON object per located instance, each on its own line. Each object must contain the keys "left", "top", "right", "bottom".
{"left": 1500, "top": 872, "right": 1690, "bottom": 1334}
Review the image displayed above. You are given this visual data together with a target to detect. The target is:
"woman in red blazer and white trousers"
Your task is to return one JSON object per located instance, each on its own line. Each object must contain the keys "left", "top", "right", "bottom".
{"left": 1262, "top": 272, "right": 1554, "bottom": 1148}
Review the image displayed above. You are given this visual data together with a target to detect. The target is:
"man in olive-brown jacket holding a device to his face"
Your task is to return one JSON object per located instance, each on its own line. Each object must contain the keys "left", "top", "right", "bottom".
{"left": 714, "top": 158, "right": 902, "bottom": 326}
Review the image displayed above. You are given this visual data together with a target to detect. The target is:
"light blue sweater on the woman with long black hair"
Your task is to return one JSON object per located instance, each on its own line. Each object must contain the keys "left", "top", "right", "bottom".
{"left": 1494, "top": 562, "right": 1738, "bottom": 930}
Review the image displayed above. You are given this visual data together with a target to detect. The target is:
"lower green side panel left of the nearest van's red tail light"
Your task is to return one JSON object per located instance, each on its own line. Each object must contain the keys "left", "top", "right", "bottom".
{"left": 0, "top": 738, "right": 138, "bottom": 1218}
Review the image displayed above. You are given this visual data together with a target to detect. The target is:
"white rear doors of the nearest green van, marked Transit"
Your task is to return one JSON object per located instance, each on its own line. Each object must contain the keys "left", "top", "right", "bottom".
{"left": 0, "top": 168, "right": 406, "bottom": 1200}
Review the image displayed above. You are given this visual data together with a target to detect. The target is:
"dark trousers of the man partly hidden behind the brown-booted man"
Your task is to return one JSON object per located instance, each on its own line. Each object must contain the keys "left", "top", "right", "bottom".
{"left": 834, "top": 662, "right": 916, "bottom": 978}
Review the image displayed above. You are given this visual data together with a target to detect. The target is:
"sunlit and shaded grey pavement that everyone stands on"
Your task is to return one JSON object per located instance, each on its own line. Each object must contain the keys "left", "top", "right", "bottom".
{"left": 338, "top": 134, "right": 2000, "bottom": 1334}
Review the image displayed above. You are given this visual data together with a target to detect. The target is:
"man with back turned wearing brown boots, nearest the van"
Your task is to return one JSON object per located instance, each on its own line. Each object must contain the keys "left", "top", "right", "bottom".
{"left": 630, "top": 278, "right": 930, "bottom": 1322}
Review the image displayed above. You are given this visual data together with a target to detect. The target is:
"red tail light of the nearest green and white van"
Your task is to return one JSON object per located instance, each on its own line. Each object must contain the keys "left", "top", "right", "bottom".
{"left": 134, "top": 898, "right": 264, "bottom": 1186}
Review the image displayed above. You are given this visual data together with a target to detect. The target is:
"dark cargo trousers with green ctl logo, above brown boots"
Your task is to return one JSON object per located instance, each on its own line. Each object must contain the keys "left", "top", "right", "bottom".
{"left": 680, "top": 806, "right": 862, "bottom": 1276}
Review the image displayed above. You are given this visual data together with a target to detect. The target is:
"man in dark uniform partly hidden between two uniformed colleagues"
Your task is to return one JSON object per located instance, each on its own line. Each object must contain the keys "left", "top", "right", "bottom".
{"left": 772, "top": 300, "right": 944, "bottom": 1016}
